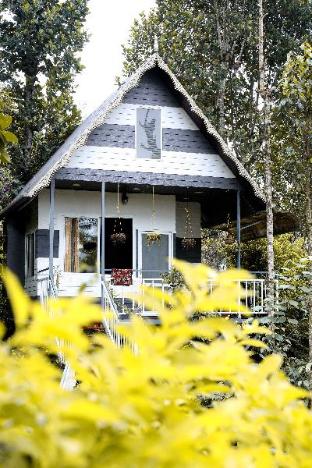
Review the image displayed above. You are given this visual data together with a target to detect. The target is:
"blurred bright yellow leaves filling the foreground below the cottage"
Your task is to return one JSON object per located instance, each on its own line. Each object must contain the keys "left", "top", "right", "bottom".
{"left": 0, "top": 263, "right": 312, "bottom": 468}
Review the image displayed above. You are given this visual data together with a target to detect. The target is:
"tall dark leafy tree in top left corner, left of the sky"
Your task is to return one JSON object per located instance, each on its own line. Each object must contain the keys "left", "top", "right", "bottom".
{"left": 0, "top": 0, "right": 88, "bottom": 189}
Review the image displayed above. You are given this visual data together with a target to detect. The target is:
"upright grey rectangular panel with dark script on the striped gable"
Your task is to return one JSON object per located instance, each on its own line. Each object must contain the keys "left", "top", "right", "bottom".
{"left": 136, "top": 108, "right": 161, "bottom": 159}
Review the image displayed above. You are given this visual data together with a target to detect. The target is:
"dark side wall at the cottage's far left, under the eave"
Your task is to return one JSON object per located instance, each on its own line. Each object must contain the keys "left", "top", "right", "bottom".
{"left": 6, "top": 219, "right": 25, "bottom": 285}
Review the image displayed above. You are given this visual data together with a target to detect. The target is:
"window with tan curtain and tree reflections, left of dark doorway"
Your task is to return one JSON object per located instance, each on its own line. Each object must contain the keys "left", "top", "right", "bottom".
{"left": 64, "top": 218, "right": 98, "bottom": 273}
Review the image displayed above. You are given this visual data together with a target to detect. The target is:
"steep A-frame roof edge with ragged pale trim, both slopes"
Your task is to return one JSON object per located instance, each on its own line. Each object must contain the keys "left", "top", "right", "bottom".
{"left": 2, "top": 53, "right": 264, "bottom": 214}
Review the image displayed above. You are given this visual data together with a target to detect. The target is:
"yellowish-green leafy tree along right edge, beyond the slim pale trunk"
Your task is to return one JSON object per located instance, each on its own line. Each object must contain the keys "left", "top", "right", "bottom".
{"left": 277, "top": 42, "right": 312, "bottom": 386}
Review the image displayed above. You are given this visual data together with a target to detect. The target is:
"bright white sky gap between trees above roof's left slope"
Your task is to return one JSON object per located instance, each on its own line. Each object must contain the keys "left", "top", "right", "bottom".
{"left": 76, "top": 0, "right": 155, "bottom": 117}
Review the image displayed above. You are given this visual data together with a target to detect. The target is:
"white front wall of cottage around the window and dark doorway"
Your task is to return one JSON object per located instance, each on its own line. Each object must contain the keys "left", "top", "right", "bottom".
{"left": 37, "top": 190, "right": 176, "bottom": 296}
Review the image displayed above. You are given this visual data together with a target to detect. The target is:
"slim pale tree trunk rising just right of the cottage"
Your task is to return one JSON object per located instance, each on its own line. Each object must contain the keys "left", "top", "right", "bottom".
{"left": 259, "top": 0, "right": 274, "bottom": 315}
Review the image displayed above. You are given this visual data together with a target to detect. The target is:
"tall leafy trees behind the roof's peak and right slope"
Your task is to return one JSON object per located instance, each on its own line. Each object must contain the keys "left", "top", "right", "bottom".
{"left": 124, "top": 0, "right": 312, "bottom": 179}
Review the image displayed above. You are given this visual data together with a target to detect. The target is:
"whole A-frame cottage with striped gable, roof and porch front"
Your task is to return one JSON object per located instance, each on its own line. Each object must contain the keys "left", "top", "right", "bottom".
{"left": 4, "top": 54, "right": 265, "bottom": 316}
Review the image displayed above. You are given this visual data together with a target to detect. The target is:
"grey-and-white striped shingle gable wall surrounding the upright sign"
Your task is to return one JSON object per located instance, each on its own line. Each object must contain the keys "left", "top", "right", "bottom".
{"left": 66, "top": 73, "right": 235, "bottom": 179}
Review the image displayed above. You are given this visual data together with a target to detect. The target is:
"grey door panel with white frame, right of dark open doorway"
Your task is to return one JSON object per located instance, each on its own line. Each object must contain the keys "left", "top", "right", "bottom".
{"left": 139, "top": 232, "right": 172, "bottom": 278}
